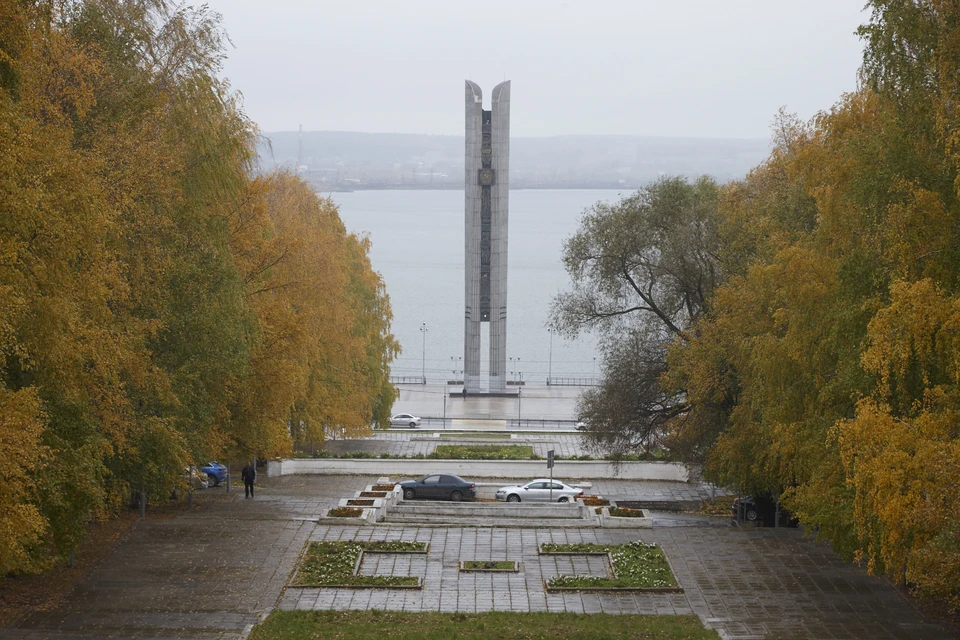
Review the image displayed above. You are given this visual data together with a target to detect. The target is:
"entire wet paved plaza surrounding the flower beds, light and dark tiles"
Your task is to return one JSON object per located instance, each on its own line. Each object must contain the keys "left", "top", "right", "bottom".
{"left": 0, "top": 476, "right": 952, "bottom": 640}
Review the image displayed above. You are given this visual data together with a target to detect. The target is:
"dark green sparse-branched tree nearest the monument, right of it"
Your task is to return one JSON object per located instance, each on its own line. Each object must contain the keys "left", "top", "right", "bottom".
{"left": 551, "top": 177, "right": 720, "bottom": 458}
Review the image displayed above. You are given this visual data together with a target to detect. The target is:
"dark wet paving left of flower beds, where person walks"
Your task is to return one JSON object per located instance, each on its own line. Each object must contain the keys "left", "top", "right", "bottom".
{"left": 6, "top": 476, "right": 376, "bottom": 640}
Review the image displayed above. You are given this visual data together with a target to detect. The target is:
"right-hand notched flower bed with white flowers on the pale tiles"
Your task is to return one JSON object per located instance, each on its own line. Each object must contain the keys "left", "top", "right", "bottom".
{"left": 540, "top": 540, "right": 683, "bottom": 593}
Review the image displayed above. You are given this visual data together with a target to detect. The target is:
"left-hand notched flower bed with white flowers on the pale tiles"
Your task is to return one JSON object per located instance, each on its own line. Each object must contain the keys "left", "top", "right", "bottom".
{"left": 291, "top": 542, "right": 427, "bottom": 589}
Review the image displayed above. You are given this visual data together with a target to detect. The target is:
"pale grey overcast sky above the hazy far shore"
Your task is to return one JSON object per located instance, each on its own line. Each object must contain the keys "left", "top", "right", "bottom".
{"left": 207, "top": 0, "right": 869, "bottom": 138}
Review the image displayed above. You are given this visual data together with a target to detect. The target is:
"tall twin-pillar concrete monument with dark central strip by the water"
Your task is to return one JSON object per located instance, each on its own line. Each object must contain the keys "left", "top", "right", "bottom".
{"left": 463, "top": 80, "right": 510, "bottom": 394}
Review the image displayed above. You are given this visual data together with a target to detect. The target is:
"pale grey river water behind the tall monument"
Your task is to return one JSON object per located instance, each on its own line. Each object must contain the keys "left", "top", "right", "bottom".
{"left": 330, "top": 189, "right": 626, "bottom": 384}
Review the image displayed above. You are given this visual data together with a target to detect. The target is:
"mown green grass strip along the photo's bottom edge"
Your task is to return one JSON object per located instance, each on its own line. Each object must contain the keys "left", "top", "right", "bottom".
{"left": 249, "top": 610, "right": 720, "bottom": 640}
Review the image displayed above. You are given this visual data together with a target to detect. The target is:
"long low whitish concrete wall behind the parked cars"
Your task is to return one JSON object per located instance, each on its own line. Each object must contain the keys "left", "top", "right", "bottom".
{"left": 267, "top": 458, "right": 689, "bottom": 482}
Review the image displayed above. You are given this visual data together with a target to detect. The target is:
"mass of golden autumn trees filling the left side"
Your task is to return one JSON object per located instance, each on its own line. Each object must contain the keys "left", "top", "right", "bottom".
{"left": 0, "top": 0, "right": 399, "bottom": 575}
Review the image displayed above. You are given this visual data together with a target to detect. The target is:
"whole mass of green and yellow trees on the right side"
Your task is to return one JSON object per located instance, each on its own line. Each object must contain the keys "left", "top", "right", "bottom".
{"left": 551, "top": 0, "right": 960, "bottom": 609}
